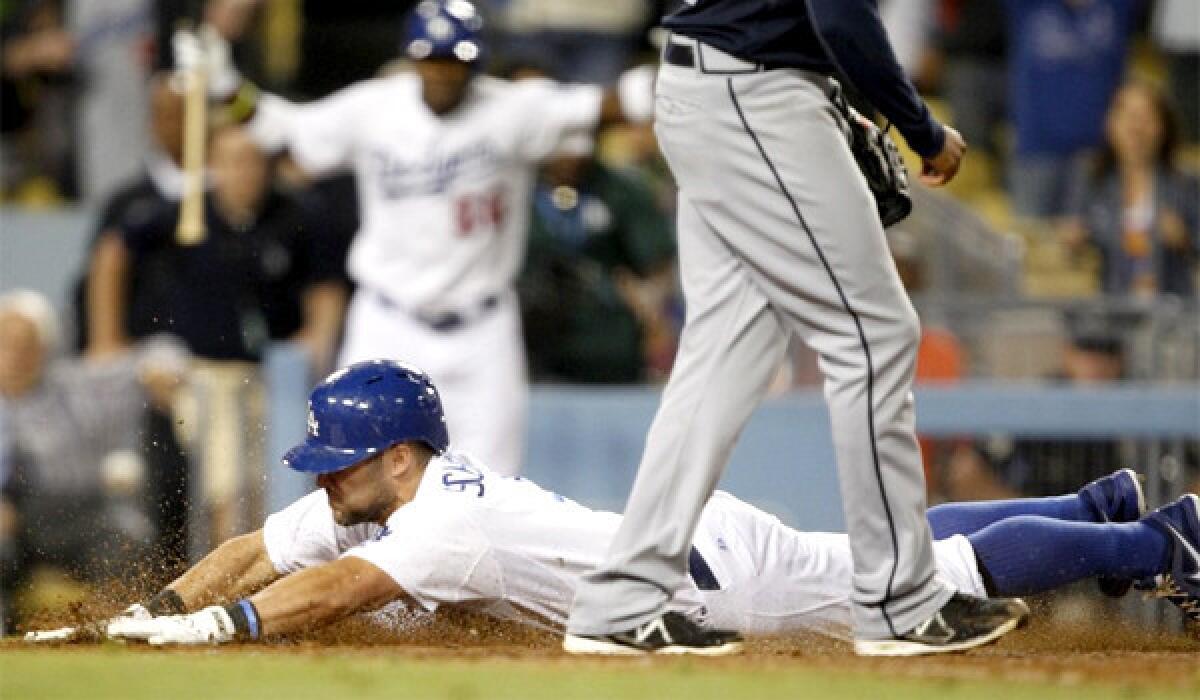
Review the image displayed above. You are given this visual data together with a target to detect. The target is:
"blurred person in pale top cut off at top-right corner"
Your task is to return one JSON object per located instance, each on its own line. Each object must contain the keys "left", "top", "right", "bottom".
{"left": 1153, "top": 0, "right": 1200, "bottom": 143}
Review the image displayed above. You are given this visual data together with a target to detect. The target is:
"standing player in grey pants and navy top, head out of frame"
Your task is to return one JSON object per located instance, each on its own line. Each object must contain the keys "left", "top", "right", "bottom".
{"left": 563, "top": 0, "right": 1024, "bottom": 656}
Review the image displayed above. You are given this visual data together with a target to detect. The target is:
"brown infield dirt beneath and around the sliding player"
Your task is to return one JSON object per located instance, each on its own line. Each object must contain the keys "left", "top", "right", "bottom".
{"left": 11, "top": 590, "right": 1200, "bottom": 698}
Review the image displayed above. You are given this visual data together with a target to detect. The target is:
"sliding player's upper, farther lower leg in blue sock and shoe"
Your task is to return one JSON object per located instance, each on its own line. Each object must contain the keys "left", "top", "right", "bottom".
{"left": 926, "top": 469, "right": 1146, "bottom": 539}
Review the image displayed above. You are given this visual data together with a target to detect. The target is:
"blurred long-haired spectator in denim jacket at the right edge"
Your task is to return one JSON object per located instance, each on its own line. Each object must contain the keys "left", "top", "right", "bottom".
{"left": 1064, "top": 82, "right": 1200, "bottom": 298}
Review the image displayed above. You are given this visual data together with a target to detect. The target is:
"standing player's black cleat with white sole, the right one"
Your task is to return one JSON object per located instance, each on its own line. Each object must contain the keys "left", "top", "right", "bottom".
{"left": 854, "top": 593, "right": 1030, "bottom": 657}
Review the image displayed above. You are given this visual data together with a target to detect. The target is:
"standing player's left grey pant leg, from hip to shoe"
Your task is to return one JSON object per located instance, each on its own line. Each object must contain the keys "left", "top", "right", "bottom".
{"left": 564, "top": 65, "right": 786, "bottom": 653}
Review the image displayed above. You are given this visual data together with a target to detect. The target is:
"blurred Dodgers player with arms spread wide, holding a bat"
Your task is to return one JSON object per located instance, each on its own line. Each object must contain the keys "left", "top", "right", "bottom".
{"left": 175, "top": 0, "right": 653, "bottom": 473}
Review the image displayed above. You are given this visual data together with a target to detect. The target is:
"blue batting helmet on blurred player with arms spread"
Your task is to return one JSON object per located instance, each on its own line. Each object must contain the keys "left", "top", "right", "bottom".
{"left": 404, "top": 0, "right": 484, "bottom": 64}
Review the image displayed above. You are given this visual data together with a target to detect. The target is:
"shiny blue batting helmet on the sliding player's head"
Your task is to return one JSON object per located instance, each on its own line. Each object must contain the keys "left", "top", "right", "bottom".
{"left": 283, "top": 360, "right": 450, "bottom": 474}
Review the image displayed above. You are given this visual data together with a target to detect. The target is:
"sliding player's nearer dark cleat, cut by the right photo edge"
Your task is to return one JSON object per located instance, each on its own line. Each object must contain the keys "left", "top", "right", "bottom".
{"left": 1142, "top": 493, "right": 1200, "bottom": 623}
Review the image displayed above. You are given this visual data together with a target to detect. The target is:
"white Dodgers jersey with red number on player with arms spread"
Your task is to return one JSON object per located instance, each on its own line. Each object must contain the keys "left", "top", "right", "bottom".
{"left": 250, "top": 73, "right": 602, "bottom": 313}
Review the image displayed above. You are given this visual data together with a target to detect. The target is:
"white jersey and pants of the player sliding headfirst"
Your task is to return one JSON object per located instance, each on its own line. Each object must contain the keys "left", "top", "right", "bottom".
{"left": 263, "top": 455, "right": 984, "bottom": 635}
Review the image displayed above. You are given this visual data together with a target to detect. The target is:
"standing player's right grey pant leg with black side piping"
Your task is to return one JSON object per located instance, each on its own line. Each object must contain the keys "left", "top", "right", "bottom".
{"left": 715, "top": 72, "right": 966, "bottom": 653}
